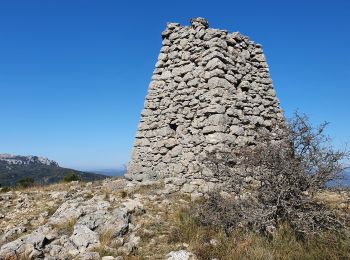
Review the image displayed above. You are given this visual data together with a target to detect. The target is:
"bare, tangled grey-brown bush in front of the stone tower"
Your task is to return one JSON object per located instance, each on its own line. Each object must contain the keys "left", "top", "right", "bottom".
{"left": 196, "top": 114, "right": 348, "bottom": 235}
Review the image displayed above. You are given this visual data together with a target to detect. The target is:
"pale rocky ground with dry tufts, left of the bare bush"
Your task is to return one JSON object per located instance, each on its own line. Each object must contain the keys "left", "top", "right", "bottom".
{"left": 0, "top": 179, "right": 208, "bottom": 260}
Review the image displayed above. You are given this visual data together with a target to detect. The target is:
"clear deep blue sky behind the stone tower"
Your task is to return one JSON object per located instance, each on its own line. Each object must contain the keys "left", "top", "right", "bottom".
{"left": 0, "top": 0, "right": 350, "bottom": 169}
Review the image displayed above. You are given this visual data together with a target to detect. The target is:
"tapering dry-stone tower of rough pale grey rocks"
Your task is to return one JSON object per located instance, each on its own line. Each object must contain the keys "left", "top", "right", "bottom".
{"left": 126, "top": 18, "right": 284, "bottom": 180}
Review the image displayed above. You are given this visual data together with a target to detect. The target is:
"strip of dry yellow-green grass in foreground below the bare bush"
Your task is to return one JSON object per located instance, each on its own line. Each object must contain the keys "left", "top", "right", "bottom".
{"left": 168, "top": 205, "right": 350, "bottom": 260}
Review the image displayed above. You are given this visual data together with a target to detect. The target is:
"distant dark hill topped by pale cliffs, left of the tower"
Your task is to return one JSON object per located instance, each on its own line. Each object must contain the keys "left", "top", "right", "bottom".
{"left": 0, "top": 154, "right": 108, "bottom": 187}
